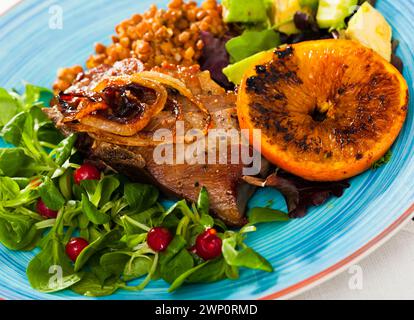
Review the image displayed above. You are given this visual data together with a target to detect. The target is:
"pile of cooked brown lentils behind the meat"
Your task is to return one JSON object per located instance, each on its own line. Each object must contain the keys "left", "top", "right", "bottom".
{"left": 53, "top": 0, "right": 227, "bottom": 92}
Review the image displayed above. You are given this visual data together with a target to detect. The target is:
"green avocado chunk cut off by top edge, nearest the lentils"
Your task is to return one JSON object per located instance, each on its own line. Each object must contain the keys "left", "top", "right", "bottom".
{"left": 222, "top": 0, "right": 268, "bottom": 23}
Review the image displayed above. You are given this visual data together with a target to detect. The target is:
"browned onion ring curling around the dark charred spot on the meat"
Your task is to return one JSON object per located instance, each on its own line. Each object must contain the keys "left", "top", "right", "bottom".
{"left": 80, "top": 73, "right": 168, "bottom": 136}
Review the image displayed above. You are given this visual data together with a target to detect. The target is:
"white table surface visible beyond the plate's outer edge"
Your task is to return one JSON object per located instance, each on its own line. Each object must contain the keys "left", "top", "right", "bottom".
{"left": 0, "top": 0, "right": 414, "bottom": 300}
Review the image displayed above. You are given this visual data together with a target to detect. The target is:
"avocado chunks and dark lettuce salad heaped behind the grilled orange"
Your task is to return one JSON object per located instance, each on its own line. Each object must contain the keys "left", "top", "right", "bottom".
{"left": 199, "top": 0, "right": 403, "bottom": 90}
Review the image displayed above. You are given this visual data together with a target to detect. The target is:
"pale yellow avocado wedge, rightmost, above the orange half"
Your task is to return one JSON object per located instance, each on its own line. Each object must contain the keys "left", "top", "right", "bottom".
{"left": 345, "top": 2, "right": 392, "bottom": 61}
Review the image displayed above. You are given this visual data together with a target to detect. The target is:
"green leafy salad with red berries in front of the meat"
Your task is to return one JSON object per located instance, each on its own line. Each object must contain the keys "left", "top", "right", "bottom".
{"left": 0, "top": 85, "right": 288, "bottom": 296}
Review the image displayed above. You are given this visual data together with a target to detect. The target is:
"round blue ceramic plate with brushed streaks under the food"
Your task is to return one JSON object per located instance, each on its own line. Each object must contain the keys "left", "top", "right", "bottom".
{"left": 0, "top": 0, "right": 414, "bottom": 299}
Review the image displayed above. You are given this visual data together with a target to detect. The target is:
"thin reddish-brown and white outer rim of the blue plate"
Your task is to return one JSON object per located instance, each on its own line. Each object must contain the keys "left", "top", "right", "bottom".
{"left": 0, "top": 0, "right": 414, "bottom": 300}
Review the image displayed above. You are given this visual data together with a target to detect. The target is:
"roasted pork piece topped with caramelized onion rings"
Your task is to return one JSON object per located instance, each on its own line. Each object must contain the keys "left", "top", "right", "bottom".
{"left": 44, "top": 59, "right": 265, "bottom": 226}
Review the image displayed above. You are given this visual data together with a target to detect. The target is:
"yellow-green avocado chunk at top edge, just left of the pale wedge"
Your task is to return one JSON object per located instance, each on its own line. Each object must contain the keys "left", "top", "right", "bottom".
{"left": 316, "top": 0, "right": 358, "bottom": 29}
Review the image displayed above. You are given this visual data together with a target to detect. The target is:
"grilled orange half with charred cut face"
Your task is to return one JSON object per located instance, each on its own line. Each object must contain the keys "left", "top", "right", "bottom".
{"left": 237, "top": 40, "right": 408, "bottom": 181}
